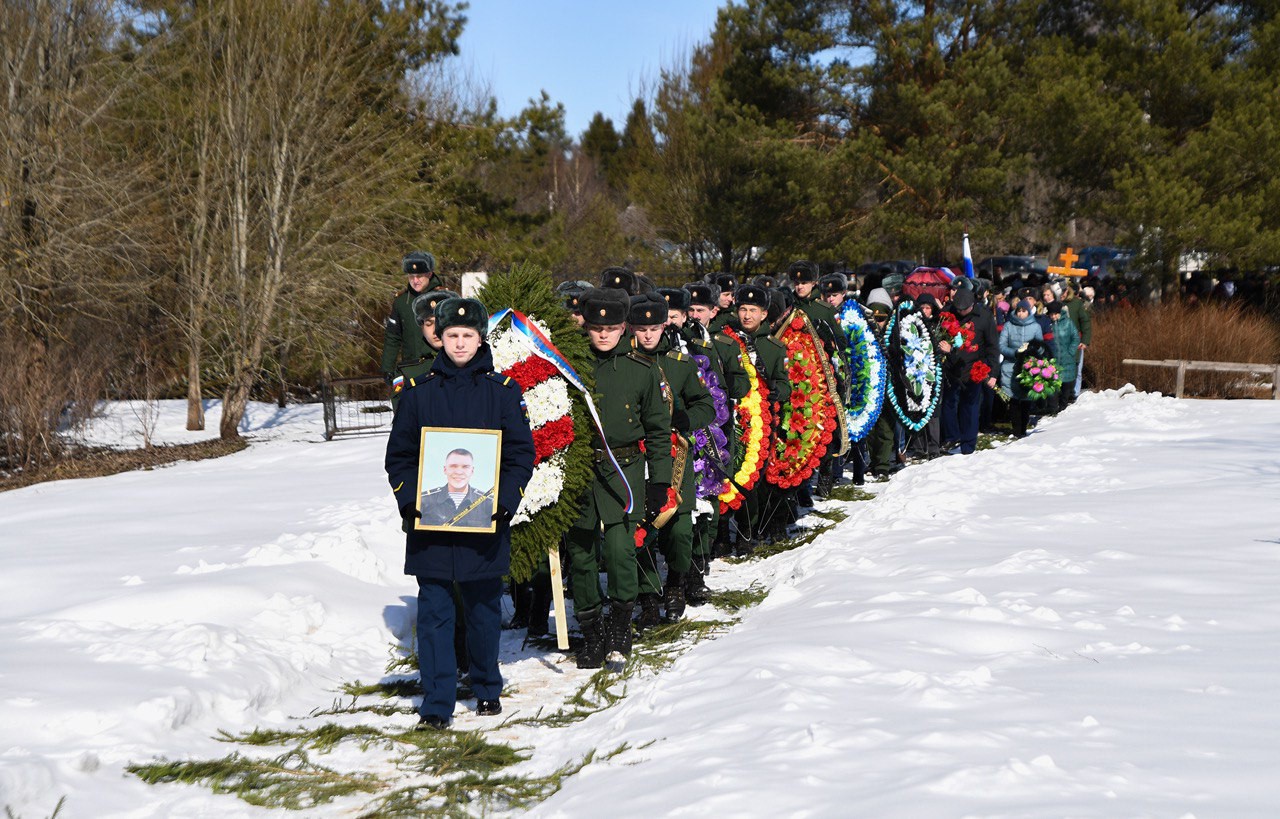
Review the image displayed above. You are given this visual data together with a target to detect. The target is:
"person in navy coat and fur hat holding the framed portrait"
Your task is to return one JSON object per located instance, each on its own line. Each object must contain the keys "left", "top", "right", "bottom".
{"left": 385, "top": 298, "right": 534, "bottom": 728}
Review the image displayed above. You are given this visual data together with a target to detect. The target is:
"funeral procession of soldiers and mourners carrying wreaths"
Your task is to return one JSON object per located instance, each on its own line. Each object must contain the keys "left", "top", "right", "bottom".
{"left": 381, "top": 252, "right": 1092, "bottom": 728}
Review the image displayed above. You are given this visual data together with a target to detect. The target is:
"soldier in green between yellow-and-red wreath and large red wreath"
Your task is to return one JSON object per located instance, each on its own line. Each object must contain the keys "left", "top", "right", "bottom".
{"left": 728, "top": 284, "right": 791, "bottom": 555}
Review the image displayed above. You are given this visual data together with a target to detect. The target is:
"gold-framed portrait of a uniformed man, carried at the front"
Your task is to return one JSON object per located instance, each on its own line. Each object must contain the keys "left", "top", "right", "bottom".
{"left": 413, "top": 426, "right": 502, "bottom": 532}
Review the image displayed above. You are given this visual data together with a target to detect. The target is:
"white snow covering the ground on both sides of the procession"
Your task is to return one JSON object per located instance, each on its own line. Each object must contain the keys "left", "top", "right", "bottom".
{"left": 0, "top": 393, "right": 1280, "bottom": 818}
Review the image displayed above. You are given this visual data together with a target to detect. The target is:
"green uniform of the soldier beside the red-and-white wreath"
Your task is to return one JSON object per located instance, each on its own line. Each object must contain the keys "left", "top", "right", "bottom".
{"left": 566, "top": 335, "right": 671, "bottom": 621}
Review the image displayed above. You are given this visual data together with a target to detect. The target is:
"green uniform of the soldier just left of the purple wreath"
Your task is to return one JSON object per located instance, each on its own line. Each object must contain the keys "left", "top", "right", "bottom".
{"left": 637, "top": 334, "right": 716, "bottom": 617}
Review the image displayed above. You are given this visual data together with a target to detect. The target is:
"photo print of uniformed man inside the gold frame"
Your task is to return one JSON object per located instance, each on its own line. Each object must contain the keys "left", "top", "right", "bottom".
{"left": 417, "top": 440, "right": 498, "bottom": 532}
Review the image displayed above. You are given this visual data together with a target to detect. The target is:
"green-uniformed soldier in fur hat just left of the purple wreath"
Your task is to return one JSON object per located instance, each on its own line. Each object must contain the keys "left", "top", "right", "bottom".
{"left": 631, "top": 290, "right": 716, "bottom": 630}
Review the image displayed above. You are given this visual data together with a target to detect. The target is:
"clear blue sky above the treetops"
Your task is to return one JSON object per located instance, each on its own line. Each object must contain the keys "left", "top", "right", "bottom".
{"left": 460, "top": 0, "right": 726, "bottom": 137}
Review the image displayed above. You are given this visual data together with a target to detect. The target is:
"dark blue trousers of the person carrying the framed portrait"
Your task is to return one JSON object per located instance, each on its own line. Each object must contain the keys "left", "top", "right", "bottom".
{"left": 417, "top": 577, "right": 502, "bottom": 720}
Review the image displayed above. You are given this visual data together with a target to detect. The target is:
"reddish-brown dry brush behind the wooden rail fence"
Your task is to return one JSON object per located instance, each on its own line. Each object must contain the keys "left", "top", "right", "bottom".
{"left": 1084, "top": 302, "right": 1280, "bottom": 398}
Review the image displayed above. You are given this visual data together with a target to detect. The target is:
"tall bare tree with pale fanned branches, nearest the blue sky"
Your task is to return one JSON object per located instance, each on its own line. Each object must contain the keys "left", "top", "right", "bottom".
{"left": 175, "top": 0, "right": 421, "bottom": 438}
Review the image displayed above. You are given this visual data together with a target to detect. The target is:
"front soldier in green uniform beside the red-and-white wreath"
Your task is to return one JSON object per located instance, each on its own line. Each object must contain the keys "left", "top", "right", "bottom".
{"left": 564, "top": 289, "right": 671, "bottom": 668}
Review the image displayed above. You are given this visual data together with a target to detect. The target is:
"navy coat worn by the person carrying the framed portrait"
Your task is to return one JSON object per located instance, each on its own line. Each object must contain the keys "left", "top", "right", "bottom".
{"left": 385, "top": 344, "right": 534, "bottom": 580}
